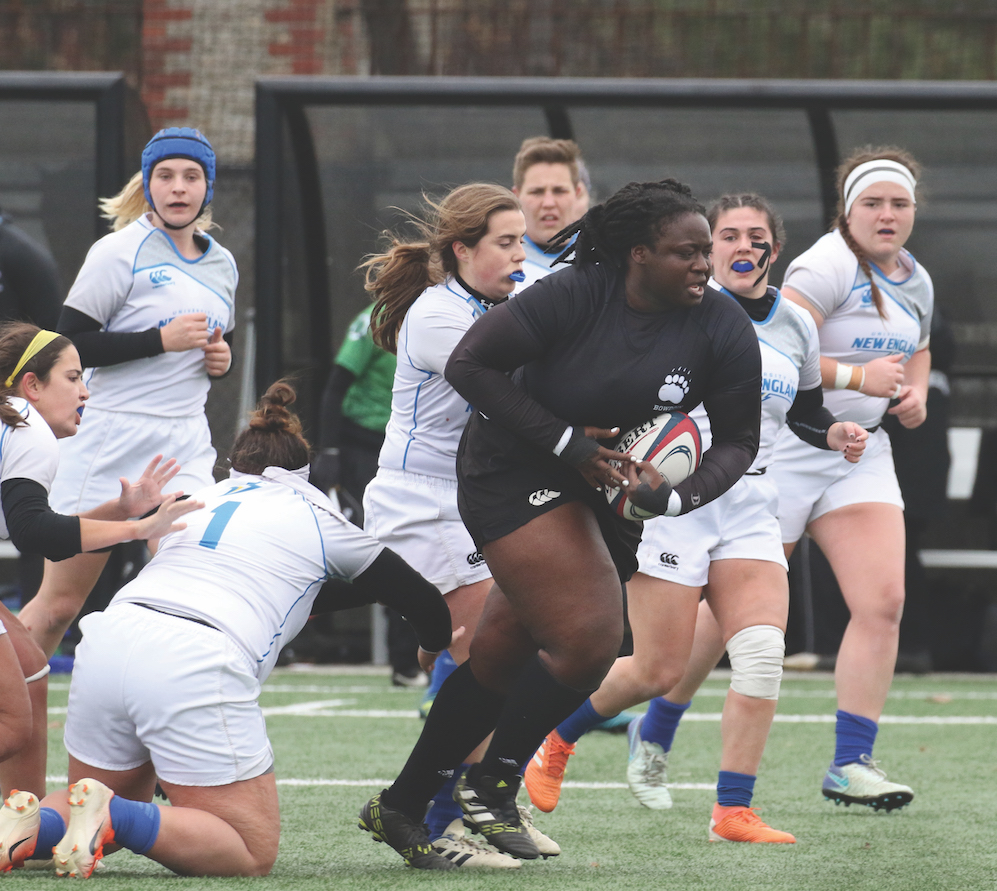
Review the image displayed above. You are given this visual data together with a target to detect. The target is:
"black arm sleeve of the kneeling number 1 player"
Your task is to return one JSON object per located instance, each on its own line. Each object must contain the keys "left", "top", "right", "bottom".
{"left": 312, "top": 548, "right": 453, "bottom": 653}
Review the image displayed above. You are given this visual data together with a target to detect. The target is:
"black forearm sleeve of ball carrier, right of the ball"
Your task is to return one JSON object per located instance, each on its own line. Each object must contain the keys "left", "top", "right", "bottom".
{"left": 675, "top": 388, "right": 761, "bottom": 514}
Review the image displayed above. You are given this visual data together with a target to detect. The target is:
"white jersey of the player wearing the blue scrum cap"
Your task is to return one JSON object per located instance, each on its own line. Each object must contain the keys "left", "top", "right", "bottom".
{"left": 66, "top": 215, "right": 239, "bottom": 417}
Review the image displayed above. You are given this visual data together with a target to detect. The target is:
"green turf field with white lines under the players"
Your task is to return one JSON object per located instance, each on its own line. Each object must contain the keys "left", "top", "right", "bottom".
{"left": 19, "top": 670, "right": 997, "bottom": 891}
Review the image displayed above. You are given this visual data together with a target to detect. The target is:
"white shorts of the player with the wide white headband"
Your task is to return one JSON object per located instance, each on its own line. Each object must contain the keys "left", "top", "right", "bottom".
{"left": 768, "top": 430, "right": 904, "bottom": 542}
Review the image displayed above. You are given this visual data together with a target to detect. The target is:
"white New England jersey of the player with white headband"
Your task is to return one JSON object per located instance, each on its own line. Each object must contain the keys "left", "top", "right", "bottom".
{"left": 783, "top": 229, "right": 935, "bottom": 428}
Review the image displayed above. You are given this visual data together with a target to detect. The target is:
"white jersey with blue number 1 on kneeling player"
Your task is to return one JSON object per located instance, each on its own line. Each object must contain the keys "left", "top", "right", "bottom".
{"left": 112, "top": 467, "right": 384, "bottom": 681}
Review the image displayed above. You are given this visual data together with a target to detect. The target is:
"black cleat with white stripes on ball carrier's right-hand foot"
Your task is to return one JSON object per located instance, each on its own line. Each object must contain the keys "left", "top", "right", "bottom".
{"left": 454, "top": 764, "right": 540, "bottom": 860}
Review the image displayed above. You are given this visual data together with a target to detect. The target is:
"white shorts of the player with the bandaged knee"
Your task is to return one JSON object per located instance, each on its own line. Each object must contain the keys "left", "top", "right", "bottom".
{"left": 637, "top": 470, "right": 788, "bottom": 588}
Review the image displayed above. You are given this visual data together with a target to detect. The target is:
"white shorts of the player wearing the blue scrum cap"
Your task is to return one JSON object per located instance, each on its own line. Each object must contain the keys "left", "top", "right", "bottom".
{"left": 49, "top": 406, "right": 216, "bottom": 514}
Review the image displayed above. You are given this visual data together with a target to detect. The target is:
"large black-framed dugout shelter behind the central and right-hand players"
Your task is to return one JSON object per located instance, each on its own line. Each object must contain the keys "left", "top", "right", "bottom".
{"left": 256, "top": 77, "right": 997, "bottom": 434}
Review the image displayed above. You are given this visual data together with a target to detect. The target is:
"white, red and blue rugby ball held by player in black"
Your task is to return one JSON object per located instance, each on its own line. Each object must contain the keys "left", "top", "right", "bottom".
{"left": 606, "top": 411, "right": 703, "bottom": 520}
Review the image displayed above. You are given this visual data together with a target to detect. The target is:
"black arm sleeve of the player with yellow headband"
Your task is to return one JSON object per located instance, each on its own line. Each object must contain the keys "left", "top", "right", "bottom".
{"left": 0, "top": 479, "right": 83, "bottom": 561}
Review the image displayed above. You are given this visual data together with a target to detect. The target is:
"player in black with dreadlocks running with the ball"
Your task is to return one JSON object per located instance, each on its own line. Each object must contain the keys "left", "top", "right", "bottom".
{"left": 361, "top": 180, "right": 761, "bottom": 868}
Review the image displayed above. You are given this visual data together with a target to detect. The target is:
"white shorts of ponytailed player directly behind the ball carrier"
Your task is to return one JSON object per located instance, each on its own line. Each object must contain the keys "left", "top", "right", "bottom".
{"left": 363, "top": 467, "right": 492, "bottom": 594}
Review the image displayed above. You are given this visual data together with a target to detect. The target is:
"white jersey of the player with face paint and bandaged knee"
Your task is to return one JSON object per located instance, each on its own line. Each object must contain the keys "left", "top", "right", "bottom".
{"left": 689, "top": 278, "right": 820, "bottom": 473}
